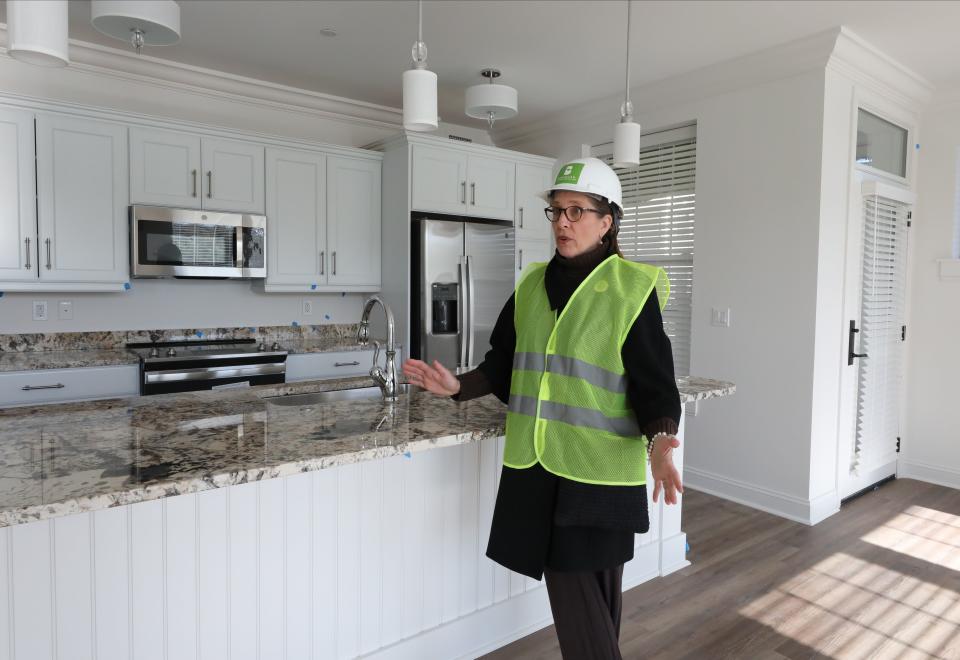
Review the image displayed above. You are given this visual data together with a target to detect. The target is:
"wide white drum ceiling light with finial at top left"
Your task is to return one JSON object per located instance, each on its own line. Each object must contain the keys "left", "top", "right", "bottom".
{"left": 90, "top": 0, "right": 180, "bottom": 55}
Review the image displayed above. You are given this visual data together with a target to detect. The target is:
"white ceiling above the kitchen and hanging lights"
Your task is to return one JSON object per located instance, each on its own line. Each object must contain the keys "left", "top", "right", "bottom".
{"left": 0, "top": 0, "right": 960, "bottom": 126}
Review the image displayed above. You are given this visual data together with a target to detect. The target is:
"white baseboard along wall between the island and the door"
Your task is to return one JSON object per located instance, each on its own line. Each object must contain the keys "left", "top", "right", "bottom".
{"left": 683, "top": 465, "right": 840, "bottom": 525}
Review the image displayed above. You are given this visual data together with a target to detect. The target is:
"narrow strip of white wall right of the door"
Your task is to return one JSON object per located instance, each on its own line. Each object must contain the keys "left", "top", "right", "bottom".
{"left": 900, "top": 96, "right": 960, "bottom": 488}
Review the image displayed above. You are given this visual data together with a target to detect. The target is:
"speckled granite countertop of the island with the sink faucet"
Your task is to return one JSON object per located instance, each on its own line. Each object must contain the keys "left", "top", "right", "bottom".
{"left": 0, "top": 377, "right": 735, "bottom": 526}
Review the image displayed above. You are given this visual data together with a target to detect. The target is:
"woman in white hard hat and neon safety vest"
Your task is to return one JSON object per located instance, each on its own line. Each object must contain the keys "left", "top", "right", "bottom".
{"left": 403, "top": 158, "right": 683, "bottom": 659}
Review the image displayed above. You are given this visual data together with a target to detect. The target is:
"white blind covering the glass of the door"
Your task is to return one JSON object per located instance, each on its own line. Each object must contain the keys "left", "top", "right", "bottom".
{"left": 850, "top": 195, "right": 908, "bottom": 474}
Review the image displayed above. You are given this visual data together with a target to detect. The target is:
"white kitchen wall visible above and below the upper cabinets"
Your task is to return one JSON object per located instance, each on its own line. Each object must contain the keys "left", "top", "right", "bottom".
{"left": 0, "top": 25, "right": 491, "bottom": 334}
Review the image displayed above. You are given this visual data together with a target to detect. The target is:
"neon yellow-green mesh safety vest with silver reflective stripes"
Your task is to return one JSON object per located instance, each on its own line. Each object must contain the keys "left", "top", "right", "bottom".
{"left": 503, "top": 255, "right": 670, "bottom": 486}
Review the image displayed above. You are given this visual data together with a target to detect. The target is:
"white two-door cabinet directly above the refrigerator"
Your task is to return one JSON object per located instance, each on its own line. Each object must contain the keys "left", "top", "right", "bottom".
{"left": 412, "top": 144, "right": 516, "bottom": 220}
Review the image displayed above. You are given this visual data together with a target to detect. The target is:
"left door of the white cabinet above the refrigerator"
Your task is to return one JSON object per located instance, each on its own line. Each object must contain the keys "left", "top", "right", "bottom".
{"left": 412, "top": 144, "right": 468, "bottom": 214}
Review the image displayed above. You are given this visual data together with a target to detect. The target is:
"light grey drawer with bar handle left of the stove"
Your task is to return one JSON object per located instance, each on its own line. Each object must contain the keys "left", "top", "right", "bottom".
{"left": 0, "top": 365, "right": 140, "bottom": 406}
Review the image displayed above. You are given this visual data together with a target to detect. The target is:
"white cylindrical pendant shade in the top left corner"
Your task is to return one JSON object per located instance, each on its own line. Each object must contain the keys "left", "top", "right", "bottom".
{"left": 7, "top": 0, "right": 70, "bottom": 66}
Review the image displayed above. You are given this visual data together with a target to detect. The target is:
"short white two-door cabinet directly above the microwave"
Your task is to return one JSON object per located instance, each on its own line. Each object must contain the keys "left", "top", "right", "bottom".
{"left": 130, "top": 128, "right": 264, "bottom": 214}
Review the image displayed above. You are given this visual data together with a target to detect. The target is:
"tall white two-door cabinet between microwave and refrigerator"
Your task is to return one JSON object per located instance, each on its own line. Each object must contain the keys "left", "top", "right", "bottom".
{"left": 265, "top": 149, "right": 381, "bottom": 291}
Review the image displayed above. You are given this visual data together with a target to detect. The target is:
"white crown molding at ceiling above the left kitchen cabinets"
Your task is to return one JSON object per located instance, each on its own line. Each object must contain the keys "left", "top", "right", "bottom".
{"left": 0, "top": 23, "right": 402, "bottom": 129}
